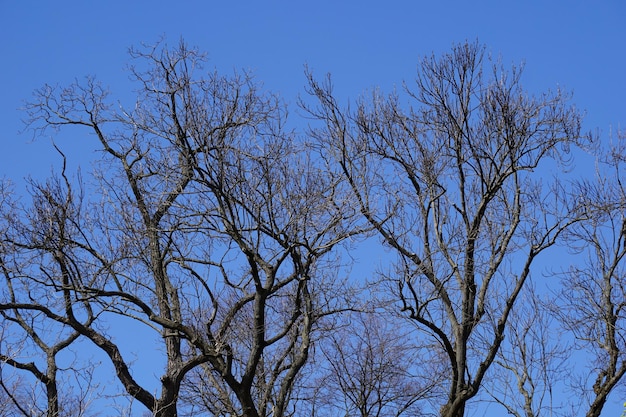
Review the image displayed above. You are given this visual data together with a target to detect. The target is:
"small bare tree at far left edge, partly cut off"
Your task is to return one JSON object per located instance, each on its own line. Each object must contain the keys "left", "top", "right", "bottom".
{"left": 0, "top": 171, "right": 99, "bottom": 417}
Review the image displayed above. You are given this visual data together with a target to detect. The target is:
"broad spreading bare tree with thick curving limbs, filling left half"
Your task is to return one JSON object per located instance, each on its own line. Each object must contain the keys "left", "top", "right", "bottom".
{"left": 0, "top": 42, "right": 358, "bottom": 417}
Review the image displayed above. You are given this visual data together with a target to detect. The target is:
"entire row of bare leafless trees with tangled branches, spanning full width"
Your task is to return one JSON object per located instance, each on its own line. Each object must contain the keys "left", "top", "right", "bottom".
{"left": 0, "top": 38, "right": 626, "bottom": 417}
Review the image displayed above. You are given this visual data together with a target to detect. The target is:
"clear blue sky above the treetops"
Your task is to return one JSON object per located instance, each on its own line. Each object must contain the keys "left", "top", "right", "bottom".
{"left": 0, "top": 0, "right": 626, "bottom": 416}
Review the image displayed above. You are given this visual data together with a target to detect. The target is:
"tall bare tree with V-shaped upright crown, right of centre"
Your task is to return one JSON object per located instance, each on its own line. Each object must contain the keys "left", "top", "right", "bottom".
{"left": 303, "top": 40, "right": 580, "bottom": 417}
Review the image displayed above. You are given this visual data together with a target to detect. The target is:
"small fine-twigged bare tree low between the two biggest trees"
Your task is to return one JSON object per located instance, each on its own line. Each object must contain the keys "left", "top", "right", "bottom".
{"left": 316, "top": 312, "right": 443, "bottom": 417}
